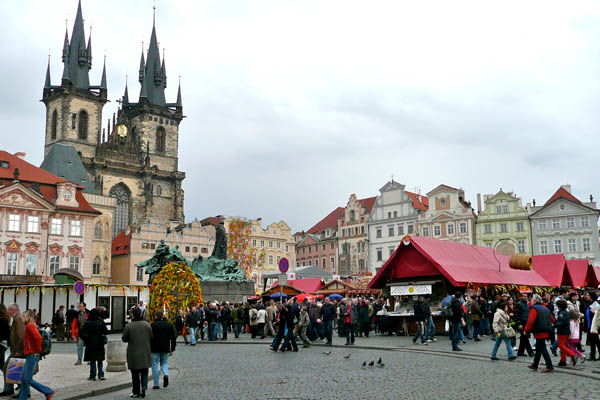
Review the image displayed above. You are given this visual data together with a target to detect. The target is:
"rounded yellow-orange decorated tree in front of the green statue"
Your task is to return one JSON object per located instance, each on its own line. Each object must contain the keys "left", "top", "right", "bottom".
{"left": 148, "top": 262, "right": 202, "bottom": 324}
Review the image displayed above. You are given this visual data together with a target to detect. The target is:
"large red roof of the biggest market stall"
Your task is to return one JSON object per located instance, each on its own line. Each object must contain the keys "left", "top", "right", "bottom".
{"left": 369, "top": 236, "right": 550, "bottom": 289}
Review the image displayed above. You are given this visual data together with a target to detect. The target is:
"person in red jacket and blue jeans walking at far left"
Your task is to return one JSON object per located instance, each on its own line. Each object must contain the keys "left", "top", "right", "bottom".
{"left": 19, "top": 310, "right": 54, "bottom": 400}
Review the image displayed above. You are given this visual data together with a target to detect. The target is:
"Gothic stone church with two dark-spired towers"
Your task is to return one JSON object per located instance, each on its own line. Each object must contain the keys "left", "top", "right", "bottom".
{"left": 42, "top": 1, "right": 185, "bottom": 237}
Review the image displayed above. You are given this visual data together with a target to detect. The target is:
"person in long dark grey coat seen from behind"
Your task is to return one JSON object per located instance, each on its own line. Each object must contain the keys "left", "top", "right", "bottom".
{"left": 121, "top": 308, "right": 152, "bottom": 398}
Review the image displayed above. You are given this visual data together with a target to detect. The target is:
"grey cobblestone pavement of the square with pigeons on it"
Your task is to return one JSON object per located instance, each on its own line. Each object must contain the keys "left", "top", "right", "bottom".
{"left": 98, "top": 337, "right": 600, "bottom": 400}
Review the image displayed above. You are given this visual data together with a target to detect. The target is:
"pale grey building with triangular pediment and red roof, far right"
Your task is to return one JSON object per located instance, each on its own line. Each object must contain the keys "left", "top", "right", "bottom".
{"left": 529, "top": 185, "right": 600, "bottom": 264}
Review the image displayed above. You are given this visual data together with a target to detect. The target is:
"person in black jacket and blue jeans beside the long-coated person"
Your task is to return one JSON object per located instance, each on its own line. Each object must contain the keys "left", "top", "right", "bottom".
{"left": 150, "top": 311, "right": 177, "bottom": 389}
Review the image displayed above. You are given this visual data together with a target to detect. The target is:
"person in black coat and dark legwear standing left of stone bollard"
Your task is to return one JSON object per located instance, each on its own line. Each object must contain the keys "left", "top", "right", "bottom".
{"left": 79, "top": 308, "right": 108, "bottom": 381}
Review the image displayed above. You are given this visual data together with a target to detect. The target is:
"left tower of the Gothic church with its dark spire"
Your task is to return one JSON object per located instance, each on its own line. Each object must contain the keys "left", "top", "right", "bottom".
{"left": 42, "top": 1, "right": 107, "bottom": 157}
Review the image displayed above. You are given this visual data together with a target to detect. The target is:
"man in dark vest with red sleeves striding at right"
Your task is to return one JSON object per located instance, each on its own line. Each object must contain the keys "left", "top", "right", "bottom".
{"left": 525, "top": 294, "right": 554, "bottom": 373}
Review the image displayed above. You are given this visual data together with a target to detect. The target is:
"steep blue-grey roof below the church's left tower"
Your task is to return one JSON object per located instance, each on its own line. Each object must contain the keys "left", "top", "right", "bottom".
{"left": 40, "top": 143, "right": 97, "bottom": 194}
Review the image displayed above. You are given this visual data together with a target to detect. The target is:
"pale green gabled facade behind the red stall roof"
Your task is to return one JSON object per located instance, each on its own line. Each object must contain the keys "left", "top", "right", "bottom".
{"left": 475, "top": 189, "right": 531, "bottom": 254}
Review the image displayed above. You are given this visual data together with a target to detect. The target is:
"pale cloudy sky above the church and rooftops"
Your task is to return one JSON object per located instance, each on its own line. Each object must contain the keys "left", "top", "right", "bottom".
{"left": 0, "top": 0, "right": 600, "bottom": 232}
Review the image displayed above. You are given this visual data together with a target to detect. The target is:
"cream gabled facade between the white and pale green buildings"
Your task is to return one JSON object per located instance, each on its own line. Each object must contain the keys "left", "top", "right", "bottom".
{"left": 417, "top": 185, "right": 475, "bottom": 244}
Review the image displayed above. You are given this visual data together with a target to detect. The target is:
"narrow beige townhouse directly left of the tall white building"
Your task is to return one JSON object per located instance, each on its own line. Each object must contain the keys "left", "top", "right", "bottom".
{"left": 337, "top": 194, "right": 375, "bottom": 276}
